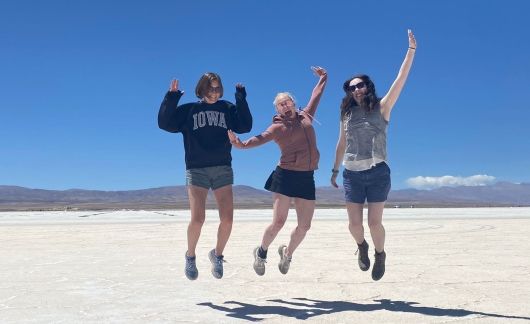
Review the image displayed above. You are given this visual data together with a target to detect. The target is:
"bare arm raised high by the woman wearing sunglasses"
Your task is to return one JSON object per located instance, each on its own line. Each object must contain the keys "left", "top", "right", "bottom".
{"left": 381, "top": 29, "right": 416, "bottom": 121}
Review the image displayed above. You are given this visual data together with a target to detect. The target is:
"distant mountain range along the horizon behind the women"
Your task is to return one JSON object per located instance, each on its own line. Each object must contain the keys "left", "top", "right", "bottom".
{"left": 0, "top": 182, "right": 530, "bottom": 210}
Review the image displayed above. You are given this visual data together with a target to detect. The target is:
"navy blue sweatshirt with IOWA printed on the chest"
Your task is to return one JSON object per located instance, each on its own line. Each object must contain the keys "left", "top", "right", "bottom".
{"left": 158, "top": 90, "right": 252, "bottom": 169}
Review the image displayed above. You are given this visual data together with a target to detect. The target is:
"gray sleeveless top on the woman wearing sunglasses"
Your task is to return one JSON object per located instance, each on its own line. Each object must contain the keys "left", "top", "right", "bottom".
{"left": 343, "top": 105, "right": 388, "bottom": 171}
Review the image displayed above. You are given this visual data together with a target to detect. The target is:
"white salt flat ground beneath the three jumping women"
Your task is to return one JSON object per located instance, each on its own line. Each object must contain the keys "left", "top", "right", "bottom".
{"left": 0, "top": 208, "right": 530, "bottom": 323}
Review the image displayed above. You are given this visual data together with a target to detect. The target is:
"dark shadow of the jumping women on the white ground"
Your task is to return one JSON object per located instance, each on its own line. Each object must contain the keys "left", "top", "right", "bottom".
{"left": 197, "top": 298, "right": 530, "bottom": 322}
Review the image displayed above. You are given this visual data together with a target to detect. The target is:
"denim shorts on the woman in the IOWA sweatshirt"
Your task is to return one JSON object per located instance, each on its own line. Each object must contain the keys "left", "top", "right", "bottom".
{"left": 186, "top": 165, "right": 234, "bottom": 190}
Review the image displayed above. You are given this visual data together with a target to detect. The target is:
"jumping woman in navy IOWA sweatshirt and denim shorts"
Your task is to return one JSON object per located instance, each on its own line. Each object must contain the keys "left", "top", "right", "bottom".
{"left": 158, "top": 73, "right": 252, "bottom": 280}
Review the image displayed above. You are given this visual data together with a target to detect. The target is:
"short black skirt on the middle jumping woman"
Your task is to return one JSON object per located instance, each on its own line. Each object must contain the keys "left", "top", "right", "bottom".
{"left": 265, "top": 167, "right": 315, "bottom": 200}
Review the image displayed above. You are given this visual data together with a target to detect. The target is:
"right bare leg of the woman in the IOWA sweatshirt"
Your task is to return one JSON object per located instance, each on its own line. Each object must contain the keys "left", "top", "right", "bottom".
{"left": 213, "top": 185, "right": 234, "bottom": 255}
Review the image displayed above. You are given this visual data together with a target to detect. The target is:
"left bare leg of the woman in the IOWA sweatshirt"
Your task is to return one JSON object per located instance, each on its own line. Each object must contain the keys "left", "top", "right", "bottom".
{"left": 186, "top": 185, "right": 208, "bottom": 257}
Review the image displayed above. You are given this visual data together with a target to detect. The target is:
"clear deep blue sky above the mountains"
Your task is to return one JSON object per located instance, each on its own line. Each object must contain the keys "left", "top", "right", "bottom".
{"left": 0, "top": 0, "right": 530, "bottom": 190}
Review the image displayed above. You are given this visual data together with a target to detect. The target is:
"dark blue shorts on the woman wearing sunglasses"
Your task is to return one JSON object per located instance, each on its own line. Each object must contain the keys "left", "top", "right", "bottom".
{"left": 342, "top": 162, "right": 391, "bottom": 204}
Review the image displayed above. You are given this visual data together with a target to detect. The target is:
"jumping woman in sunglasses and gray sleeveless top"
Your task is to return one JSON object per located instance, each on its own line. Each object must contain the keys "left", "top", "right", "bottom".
{"left": 331, "top": 29, "right": 416, "bottom": 280}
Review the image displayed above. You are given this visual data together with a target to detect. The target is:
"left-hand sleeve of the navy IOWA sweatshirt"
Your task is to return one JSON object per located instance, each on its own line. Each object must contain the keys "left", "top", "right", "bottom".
{"left": 158, "top": 90, "right": 186, "bottom": 133}
